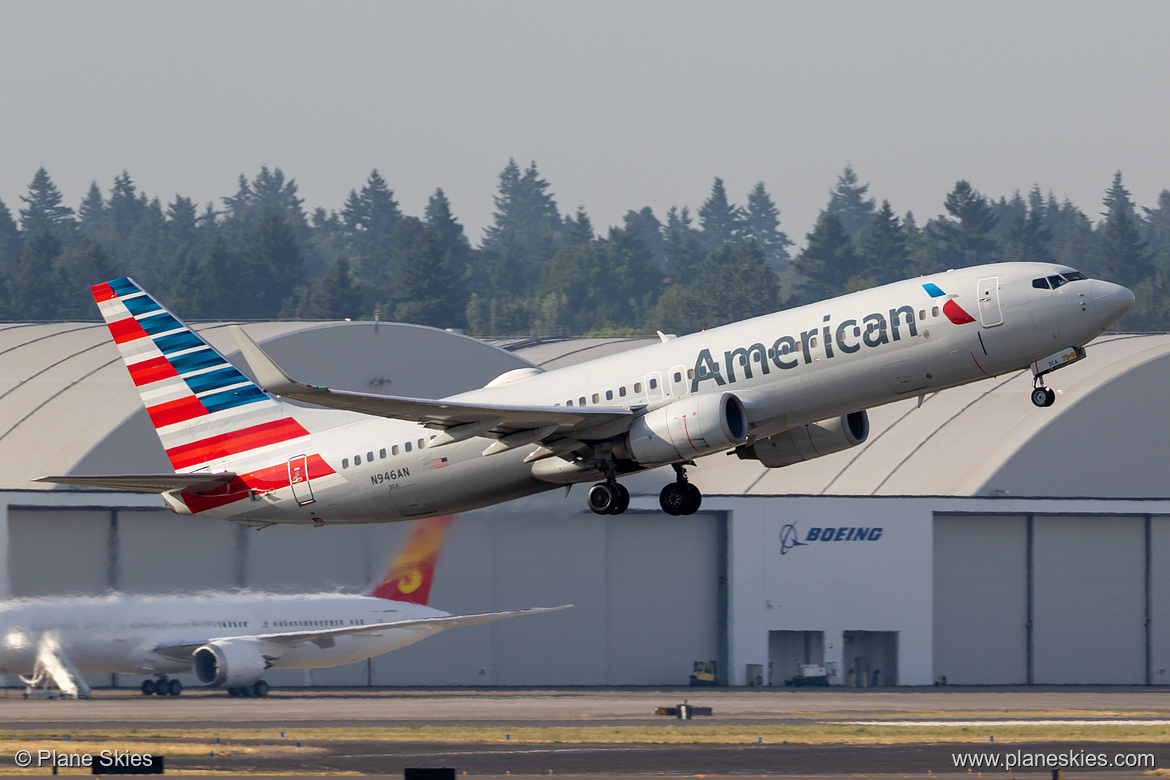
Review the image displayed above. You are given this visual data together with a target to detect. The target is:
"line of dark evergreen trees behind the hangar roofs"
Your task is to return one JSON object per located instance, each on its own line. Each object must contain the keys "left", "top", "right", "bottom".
{"left": 0, "top": 160, "right": 1170, "bottom": 337}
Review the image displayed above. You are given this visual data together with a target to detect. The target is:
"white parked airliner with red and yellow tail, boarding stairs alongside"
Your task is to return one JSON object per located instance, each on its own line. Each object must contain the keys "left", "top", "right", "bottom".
{"left": 0, "top": 517, "right": 569, "bottom": 697}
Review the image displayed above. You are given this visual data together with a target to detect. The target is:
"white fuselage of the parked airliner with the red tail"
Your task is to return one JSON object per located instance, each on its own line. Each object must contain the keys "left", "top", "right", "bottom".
{"left": 0, "top": 593, "right": 447, "bottom": 675}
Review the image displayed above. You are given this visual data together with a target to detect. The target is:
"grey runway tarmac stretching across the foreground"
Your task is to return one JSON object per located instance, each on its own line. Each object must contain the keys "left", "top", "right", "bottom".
{"left": 0, "top": 686, "right": 1170, "bottom": 780}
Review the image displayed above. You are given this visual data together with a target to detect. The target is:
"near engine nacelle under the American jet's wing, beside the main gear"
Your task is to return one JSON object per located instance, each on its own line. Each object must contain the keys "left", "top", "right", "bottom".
{"left": 614, "top": 393, "right": 748, "bottom": 465}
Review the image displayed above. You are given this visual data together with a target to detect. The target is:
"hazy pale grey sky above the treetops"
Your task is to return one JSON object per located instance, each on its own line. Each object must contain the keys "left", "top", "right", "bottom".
{"left": 0, "top": 0, "right": 1170, "bottom": 243}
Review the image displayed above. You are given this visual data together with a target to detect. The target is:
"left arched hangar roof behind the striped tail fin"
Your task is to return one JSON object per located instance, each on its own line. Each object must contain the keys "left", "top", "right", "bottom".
{"left": 0, "top": 322, "right": 529, "bottom": 489}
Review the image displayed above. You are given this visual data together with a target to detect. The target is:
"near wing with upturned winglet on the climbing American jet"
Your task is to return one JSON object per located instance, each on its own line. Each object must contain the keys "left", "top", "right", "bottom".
{"left": 232, "top": 325, "right": 633, "bottom": 441}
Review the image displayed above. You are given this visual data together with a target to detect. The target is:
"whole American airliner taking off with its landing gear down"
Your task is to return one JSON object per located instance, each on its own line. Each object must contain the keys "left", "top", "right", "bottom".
{"left": 42, "top": 263, "right": 1134, "bottom": 526}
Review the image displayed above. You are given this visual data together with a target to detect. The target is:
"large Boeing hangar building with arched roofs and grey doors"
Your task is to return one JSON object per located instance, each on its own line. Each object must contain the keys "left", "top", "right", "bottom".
{"left": 0, "top": 323, "right": 1170, "bottom": 686}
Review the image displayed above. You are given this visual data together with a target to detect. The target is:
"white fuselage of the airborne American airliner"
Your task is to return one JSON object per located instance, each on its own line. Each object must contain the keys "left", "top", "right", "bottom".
{"left": 177, "top": 263, "right": 1133, "bottom": 523}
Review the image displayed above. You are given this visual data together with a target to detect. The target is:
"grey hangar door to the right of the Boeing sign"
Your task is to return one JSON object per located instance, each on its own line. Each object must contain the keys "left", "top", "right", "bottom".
{"left": 934, "top": 515, "right": 1146, "bottom": 684}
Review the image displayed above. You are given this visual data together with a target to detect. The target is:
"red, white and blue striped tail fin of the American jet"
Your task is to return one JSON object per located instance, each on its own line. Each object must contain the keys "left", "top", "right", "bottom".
{"left": 90, "top": 277, "right": 309, "bottom": 471}
